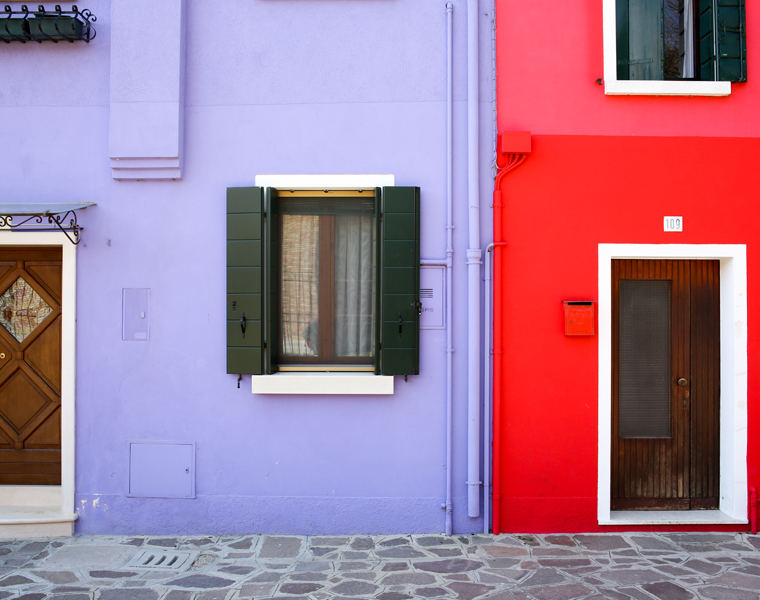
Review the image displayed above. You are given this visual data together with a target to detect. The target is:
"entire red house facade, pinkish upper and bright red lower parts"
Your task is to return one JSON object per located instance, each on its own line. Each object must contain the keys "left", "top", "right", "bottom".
{"left": 493, "top": 0, "right": 760, "bottom": 533}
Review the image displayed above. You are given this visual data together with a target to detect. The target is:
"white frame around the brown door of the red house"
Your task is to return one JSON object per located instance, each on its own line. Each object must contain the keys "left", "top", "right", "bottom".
{"left": 597, "top": 244, "right": 748, "bottom": 525}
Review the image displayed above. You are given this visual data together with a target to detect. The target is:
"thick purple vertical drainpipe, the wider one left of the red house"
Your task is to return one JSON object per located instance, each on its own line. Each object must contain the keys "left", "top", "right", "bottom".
{"left": 467, "top": 0, "right": 481, "bottom": 517}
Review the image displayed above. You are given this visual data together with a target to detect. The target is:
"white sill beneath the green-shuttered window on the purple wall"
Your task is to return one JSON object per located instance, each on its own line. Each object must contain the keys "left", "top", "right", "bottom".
{"left": 251, "top": 373, "right": 393, "bottom": 395}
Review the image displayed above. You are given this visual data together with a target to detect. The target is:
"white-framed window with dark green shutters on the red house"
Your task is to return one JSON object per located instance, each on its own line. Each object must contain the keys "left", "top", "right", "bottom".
{"left": 604, "top": 0, "right": 747, "bottom": 95}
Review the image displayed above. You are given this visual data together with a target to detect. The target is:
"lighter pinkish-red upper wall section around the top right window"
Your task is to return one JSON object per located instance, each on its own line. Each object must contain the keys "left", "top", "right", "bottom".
{"left": 496, "top": 0, "right": 760, "bottom": 137}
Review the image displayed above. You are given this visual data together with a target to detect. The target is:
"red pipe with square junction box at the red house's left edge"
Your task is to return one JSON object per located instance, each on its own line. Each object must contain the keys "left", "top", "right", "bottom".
{"left": 492, "top": 131, "right": 530, "bottom": 535}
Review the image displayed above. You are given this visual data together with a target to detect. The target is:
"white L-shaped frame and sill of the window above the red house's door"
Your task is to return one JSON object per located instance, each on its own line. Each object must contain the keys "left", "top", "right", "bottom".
{"left": 602, "top": 0, "right": 731, "bottom": 96}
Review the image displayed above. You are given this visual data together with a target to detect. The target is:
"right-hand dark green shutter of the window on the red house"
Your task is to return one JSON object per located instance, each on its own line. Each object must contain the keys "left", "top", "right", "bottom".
{"left": 715, "top": 0, "right": 747, "bottom": 82}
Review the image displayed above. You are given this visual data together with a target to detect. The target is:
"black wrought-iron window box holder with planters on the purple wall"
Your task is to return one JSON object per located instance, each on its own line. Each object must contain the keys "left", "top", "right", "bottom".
{"left": 0, "top": 4, "right": 98, "bottom": 44}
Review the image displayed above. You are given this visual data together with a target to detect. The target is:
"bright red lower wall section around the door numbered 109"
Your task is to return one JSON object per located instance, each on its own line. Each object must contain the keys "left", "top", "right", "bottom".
{"left": 494, "top": 135, "right": 760, "bottom": 532}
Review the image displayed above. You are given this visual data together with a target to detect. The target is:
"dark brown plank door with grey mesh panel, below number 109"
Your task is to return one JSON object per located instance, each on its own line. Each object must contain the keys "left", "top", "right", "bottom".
{"left": 611, "top": 260, "right": 720, "bottom": 510}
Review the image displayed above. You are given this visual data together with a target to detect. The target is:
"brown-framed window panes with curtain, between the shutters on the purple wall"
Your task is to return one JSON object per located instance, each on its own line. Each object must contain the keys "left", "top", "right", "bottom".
{"left": 278, "top": 194, "right": 375, "bottom": 364}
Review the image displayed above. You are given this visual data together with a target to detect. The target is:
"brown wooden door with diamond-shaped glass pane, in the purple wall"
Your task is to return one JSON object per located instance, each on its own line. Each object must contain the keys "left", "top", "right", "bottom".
{"left": 0, "top": 247, "right": 62, "bottom": 485}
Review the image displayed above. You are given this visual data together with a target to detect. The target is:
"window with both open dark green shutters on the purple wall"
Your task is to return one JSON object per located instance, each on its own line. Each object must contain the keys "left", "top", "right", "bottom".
{"left": 227, "top": 176, "right": 421, "bottom": 375}
